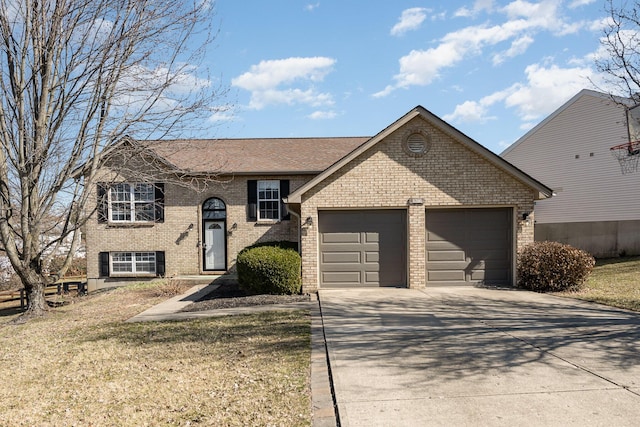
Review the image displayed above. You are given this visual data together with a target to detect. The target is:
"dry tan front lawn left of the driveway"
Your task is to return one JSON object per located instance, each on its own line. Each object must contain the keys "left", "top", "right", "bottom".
{"left": 0, "top": 287, "right": 311, "bottom": 426}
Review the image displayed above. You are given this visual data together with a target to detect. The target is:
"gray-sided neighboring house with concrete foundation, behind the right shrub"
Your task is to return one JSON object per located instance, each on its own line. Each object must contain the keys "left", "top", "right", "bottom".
{"left": 501, "top": 89, "right": 640, "bottom": 257}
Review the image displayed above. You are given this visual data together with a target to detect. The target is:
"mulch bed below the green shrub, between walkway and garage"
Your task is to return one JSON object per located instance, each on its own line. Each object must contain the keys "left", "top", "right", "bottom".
{"left": 182, "top": 280, "right": 311, "bottom": 311}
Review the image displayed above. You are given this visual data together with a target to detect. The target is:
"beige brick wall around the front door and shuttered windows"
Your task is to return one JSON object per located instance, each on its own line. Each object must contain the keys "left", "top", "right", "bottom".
{"left": 86, "top": 176, "right": 310, "bottom": 290}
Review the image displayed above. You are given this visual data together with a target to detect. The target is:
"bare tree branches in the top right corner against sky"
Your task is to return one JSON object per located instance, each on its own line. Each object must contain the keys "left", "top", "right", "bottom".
{"left": 595, "top": 0, "right": 640, "bottom": 103}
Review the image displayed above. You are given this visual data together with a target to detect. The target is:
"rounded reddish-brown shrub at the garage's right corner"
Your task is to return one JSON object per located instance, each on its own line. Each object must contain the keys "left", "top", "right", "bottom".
{"left": 517, "top": 242, "right": 596, "bottom": 292}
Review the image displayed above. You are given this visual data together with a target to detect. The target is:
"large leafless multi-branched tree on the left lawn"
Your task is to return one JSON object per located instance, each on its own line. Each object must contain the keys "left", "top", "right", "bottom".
{"left": 0, "top": 0, "right": 217, "bottom": 316}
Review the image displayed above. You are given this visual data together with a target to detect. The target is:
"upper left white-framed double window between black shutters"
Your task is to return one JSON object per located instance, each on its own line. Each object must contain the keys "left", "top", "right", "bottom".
{"left": 109, "top": 182, "right": 155, "bottom": 222}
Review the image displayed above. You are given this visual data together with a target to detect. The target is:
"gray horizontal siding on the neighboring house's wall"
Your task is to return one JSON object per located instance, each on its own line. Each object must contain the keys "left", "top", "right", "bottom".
{"left": 502, "top": 91, "right": 640, "bottom": 224}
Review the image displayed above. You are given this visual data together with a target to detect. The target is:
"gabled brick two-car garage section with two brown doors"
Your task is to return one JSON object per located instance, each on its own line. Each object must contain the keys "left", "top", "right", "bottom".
{"left": 285, "top": 107, "right": 553, "bottom": 292}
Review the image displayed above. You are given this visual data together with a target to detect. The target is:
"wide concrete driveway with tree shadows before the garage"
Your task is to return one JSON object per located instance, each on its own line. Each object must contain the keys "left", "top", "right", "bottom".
{"left": 319, "top": 287, "right": 640, "bottom": 426}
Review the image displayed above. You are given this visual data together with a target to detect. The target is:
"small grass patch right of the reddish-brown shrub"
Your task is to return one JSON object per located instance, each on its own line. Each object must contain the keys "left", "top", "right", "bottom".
{"left": 558, "top": 257, "right": 640, "bottom": 311}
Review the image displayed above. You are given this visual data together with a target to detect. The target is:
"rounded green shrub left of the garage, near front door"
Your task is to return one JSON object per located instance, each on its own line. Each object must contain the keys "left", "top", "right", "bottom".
{"left": 236, "top": 245, "right": 302, "bottom": 295}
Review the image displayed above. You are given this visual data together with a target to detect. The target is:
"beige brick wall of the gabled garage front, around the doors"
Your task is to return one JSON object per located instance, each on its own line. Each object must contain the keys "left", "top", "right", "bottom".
{"left": 301, "top": 118, "right": 534, "bottom": 292}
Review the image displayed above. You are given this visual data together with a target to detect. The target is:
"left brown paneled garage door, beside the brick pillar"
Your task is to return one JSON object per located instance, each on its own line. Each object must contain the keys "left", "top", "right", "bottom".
{"left": 318, "top": 210, "right": 406, "bottom": 288}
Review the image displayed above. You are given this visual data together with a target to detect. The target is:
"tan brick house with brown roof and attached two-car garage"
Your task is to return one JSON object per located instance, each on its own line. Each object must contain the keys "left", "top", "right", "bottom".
{"left": 86, "top": 107, "right": 551, "bottom": 292}
